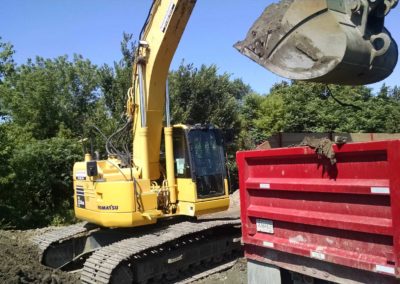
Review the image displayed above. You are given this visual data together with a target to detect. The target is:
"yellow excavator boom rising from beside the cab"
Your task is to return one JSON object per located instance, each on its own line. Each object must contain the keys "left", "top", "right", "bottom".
{"left": 127, "top": 0, "right": 196, "bottom": 180}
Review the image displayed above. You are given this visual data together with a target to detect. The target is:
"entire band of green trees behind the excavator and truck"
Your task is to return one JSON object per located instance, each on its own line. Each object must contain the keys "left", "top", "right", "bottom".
{"left": 0, "top": 34, "right": 400, "bottom": 228}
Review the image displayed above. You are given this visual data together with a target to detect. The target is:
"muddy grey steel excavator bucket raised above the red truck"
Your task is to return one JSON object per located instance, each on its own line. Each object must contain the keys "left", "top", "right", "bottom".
{"left": 235, "top": 0, "right": 398, "bottom": 85}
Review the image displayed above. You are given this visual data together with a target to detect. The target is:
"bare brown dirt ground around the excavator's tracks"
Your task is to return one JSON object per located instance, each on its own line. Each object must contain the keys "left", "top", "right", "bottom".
{"left": 0, "top": 192, "right": 247, "bottom": 284}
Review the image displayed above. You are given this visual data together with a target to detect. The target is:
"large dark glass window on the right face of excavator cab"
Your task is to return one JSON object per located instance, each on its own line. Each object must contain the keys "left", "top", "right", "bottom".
{"left": 187, "top": 128, "right": 225, "bottom": 199}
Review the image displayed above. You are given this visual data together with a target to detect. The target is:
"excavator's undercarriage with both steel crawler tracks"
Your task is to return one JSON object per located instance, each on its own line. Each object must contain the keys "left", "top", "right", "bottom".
{"left": 33, "top": 215, "right": 241, "bottom": 283}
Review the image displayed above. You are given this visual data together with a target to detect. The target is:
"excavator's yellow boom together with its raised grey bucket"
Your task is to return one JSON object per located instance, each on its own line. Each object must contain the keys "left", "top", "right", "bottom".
{"left": 127, "top": 0, "right": 398, "bottom": 182}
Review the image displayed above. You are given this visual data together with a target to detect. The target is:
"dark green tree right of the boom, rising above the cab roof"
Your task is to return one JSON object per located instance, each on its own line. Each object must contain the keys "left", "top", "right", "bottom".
{"left": 169, "top": 64, "right": 250, "bottom": 130}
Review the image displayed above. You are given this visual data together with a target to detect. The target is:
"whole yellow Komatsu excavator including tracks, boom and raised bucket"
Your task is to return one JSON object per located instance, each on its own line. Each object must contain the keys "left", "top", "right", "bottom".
{"left": 34, "top": 0, "right": 398, "bottom": 283}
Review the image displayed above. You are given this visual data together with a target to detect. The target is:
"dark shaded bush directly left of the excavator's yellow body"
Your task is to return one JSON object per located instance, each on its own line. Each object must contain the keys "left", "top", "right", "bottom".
{"left": 0, "top": 137, "right": 82, "bottom": 228}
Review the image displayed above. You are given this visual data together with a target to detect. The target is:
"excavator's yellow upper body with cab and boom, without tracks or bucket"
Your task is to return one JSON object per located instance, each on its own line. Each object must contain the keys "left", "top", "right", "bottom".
{"left": 74, "top": 0, "right": 229, "bottom": 227}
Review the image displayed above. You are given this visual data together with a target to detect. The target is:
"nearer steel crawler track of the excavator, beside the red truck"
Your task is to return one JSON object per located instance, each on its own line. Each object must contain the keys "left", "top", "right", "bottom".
{"left": 81, "top": 219, "right": 241, "bottom": 283}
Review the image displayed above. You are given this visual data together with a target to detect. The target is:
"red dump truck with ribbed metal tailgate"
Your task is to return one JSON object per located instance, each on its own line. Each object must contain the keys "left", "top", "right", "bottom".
{"left": 237, "top": 140, "right": 400, "bottom": 284}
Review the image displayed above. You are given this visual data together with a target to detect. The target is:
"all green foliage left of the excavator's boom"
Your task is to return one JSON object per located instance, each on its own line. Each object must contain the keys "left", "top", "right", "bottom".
{"left": 0, "top": 37, "right": 130, "bottom": 228}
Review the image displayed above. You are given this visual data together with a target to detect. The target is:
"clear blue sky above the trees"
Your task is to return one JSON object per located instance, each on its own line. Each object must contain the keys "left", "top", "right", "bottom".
{"left": 0, "top": 0, "right": 400, "bottom": 93}
